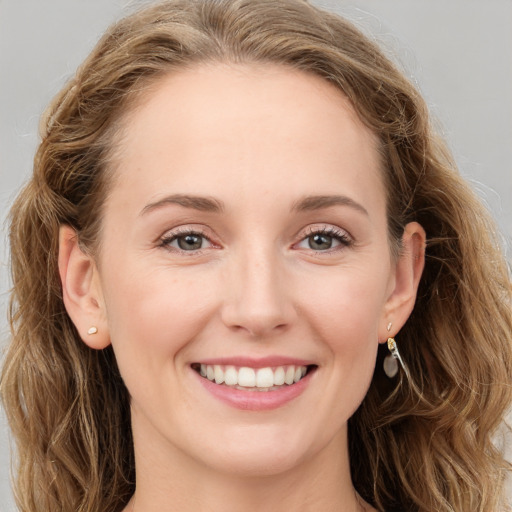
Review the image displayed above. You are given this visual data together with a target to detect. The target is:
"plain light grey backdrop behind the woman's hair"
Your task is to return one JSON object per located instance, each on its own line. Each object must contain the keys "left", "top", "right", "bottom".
{"left": 0, "top": 0, "right": 512, "bottom": 512}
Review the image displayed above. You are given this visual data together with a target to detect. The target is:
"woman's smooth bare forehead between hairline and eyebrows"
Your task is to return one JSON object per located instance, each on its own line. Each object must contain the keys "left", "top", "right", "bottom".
{"left": 107, "top": 64, "right": 382, "bottom": 214}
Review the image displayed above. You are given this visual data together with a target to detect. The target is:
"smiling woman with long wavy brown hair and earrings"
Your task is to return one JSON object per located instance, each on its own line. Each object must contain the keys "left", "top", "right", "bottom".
{"left": 2, "top": 0, "right": 512, "bottom": 512}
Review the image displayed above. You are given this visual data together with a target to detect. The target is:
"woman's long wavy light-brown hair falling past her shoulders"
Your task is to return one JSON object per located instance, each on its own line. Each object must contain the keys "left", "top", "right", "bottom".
{"left": 1, "top": 0, "right": 512, "bottom": 512}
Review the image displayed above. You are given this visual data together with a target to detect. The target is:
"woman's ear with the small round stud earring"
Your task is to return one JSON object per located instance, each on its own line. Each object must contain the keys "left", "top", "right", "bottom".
{"left": 58, "top": 225, "right": 110, "bottom": 350}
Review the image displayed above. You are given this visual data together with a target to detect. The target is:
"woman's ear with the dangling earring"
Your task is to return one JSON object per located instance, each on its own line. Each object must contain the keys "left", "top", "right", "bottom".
{"left": 379, "top": 222, "right": 426, "bottom": 343}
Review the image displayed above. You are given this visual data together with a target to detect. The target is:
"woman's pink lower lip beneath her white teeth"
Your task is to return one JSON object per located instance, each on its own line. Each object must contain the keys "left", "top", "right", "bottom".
{"left": 192, "top": 370, "right": 312, "bottom": 411}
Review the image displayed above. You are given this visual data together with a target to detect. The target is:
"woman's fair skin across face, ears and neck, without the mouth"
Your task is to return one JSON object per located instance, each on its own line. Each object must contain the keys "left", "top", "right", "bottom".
{"left": 59, "top": 64, "right": 425, "bottom": 512}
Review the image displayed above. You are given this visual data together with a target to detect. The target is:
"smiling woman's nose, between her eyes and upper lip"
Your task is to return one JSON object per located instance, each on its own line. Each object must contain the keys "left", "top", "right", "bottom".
{"left": 221, "top": 246, "right": 296, "bottom": 338}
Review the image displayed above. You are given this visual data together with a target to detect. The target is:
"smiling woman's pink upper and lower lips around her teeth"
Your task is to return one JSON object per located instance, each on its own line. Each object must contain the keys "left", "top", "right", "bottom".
{"left": 191, "top": 358, "right": 315, "bottom": 411}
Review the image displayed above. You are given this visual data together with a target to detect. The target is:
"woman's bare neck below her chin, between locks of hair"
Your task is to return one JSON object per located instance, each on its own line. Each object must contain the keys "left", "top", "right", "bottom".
{"left": 125, "top": 420, "right": 369, "bottom": 512}
